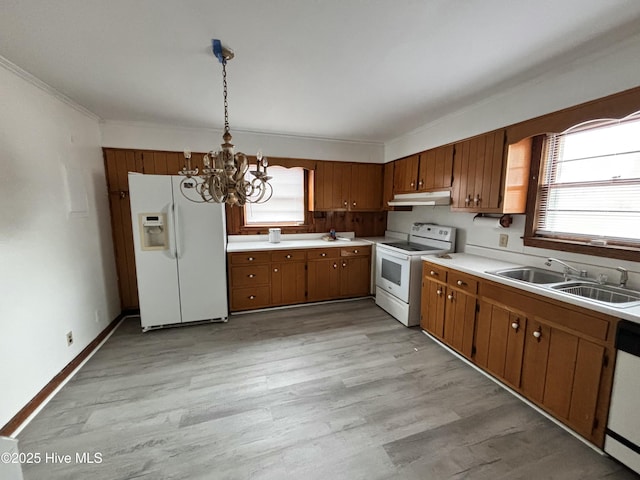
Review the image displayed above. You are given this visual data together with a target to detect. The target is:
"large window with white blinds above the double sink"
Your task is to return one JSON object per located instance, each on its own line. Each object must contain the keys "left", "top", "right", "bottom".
{"left": 535, "top": 114, "right": 640, "bottom": 246}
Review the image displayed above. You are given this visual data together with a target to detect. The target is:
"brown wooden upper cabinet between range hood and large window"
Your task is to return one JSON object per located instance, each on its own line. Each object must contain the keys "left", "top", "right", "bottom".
{"left": 451, "top": 129, "right": 531, "bottom": 213}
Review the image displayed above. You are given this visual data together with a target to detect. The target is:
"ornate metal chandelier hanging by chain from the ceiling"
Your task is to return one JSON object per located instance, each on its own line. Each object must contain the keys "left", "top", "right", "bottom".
{"left": 178, "top": 39, "right": 273, "bottom": 206}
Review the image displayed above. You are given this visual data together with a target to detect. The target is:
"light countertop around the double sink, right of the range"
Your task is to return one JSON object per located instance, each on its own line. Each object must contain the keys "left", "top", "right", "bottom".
{"left": 421, "top": 253, "right": 640, "bottom": 323}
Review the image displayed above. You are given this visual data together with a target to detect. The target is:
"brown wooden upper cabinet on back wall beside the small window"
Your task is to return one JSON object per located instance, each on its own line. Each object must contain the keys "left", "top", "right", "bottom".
{"left": 309, "top": 161, "right": 384, "bottom": 212}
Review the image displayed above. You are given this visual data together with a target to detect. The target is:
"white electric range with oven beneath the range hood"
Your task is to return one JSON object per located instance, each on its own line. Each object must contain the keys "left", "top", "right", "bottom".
{"left": 376, "top": 223, "right": 456, "bottom": 327}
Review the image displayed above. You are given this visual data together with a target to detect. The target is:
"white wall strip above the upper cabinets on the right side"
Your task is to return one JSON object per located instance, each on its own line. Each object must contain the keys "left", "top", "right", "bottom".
{"left": 384, "top": 31, "right": 640, "bottom": 162}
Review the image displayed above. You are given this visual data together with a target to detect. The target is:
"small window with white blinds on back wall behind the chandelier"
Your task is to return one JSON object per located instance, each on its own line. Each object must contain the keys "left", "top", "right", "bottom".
{"left": 244, "top": 166, "right": 304, "bottom": 226}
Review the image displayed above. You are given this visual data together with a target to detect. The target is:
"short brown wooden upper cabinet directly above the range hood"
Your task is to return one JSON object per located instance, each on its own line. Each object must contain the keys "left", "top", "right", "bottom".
{"left": 393, "top": 145, "right": 453, "bottom": 193}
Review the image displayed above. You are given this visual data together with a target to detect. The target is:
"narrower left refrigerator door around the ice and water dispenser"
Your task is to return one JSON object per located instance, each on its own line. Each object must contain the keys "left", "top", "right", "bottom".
{"left": 129, "top": 173, "right": 181, "bottom": 328}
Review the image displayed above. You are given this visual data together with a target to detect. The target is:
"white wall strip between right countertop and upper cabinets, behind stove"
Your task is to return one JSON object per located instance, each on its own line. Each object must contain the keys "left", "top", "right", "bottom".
{"left": 387, "top": 207, "right": 640, "bottom": 289}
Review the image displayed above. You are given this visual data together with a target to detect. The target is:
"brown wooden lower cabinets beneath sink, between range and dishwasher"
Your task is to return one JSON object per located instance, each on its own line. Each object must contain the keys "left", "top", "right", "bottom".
{"left": 421, "top": 262, "right": 618, "bottom": 447}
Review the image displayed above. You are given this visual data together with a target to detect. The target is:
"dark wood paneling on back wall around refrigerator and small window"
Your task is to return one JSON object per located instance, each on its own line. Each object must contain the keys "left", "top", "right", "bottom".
{"left": 103, "top": 148, "right": 387, "bottom": 311}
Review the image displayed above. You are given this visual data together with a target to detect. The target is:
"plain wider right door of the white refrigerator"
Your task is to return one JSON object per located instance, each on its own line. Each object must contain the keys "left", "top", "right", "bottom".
{"left": 171, "top": 176, "right": 228, "bottom": 322}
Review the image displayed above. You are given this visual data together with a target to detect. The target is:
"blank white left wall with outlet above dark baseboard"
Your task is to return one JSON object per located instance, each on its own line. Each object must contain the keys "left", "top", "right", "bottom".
{"left": 0, "top": 62, "right": 120, "bottom": 426}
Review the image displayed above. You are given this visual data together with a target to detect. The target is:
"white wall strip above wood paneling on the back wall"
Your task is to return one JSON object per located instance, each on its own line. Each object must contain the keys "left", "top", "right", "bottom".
{"left": 100, "top": 121, "right": 384, "bottom": 163}
